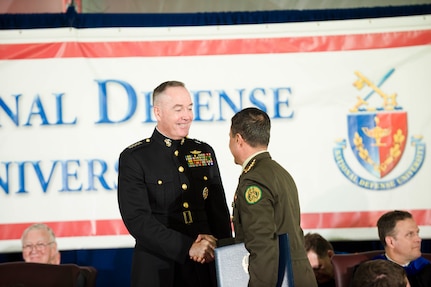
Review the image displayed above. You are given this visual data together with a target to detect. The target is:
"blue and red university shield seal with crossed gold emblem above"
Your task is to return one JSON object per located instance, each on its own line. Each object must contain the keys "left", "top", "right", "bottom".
{"left": 333, "top": 69, "right": 426, "bottom": 190}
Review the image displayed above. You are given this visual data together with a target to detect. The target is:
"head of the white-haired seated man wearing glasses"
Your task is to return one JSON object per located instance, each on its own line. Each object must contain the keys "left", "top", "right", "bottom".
{"left": 21, "top": 223, "right": 60, "bottom": 264}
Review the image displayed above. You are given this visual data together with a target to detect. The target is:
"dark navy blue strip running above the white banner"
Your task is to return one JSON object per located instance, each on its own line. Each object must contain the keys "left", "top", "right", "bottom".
{"left": 0, "top": 4, "right": 431, "bottom": 29}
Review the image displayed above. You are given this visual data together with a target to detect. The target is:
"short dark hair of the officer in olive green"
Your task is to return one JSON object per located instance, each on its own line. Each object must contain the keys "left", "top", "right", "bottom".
{"left": 231, "top": 108, "right": 271, "bottom": 147}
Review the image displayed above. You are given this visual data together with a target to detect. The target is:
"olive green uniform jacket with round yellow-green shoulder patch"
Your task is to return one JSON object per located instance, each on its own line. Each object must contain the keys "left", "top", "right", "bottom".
{"left": 233, "top": 152, "right": 317, "bottom": 287}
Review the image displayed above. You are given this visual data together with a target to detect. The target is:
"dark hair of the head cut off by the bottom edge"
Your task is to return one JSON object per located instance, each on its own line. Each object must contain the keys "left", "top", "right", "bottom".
{"left": 352, "top": 259, "right": 407, "bottom": 287}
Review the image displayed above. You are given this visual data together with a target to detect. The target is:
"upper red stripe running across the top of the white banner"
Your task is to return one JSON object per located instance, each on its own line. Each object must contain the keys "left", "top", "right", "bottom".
{"left": 0, "top": 30, "right": 431, "bottom": 60}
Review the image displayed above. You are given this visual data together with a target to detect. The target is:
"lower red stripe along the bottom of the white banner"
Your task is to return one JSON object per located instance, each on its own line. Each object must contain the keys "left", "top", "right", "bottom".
{"left": 0, "top": 209, "right": 431, "bottom": 240}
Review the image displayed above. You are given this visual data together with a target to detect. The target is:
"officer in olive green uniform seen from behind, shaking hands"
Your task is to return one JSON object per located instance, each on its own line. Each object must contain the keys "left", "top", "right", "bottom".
{"left": 229, "top": 108, "right": 317, "bottom": 287}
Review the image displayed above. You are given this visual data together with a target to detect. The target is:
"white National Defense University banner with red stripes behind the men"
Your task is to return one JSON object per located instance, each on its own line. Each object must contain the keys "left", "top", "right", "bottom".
{"left": 0, "top": 16, "right": 431, "bottom": 252}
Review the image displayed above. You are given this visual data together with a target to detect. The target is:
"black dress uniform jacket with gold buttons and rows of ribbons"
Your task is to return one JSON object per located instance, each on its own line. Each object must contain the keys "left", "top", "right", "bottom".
{"left": 118, "top": 129, "right": 232, "bottom": 287}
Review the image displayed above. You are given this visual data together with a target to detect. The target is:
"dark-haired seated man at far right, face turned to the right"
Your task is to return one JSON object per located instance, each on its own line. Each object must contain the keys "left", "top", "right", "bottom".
{"left": 375, "top": 210, "right": 431, "bottom": 287}
